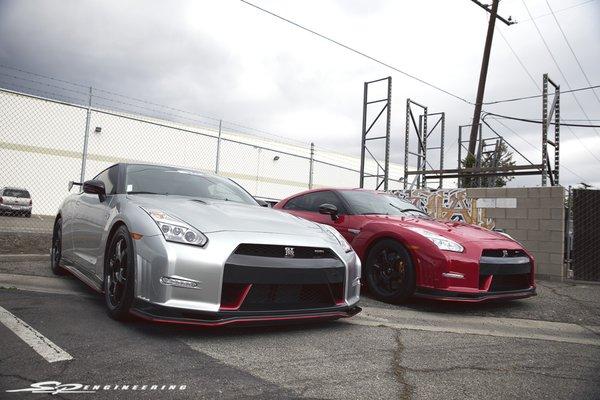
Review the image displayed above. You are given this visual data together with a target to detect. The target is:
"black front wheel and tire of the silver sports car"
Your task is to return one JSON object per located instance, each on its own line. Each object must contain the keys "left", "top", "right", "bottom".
{"left": 104, "top": 225, "right": 135, "bottom": 321}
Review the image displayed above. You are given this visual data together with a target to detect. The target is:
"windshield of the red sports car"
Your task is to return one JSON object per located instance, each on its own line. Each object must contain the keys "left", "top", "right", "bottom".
{"left": 340, "top": 190, "right": 427, "bottom": 216}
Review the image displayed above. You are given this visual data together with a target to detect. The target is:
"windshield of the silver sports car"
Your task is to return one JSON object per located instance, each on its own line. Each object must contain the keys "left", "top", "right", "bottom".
{"left": 125, "top": 165, "right": 258, "bottom": 205}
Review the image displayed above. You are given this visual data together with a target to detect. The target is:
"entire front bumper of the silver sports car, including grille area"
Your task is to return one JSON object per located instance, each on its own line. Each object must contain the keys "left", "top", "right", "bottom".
{"left": 132, "top": 232, "right": 361, "bottom": 325}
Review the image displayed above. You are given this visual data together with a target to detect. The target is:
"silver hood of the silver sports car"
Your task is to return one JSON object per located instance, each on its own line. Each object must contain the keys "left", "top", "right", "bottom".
{"left": 127, "top": 195, "right": 322, "bottom": 236}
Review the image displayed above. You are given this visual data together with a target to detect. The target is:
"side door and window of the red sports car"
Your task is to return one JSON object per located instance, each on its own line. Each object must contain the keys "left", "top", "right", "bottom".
{"left": 283, "top": 190, "right": 354, "bottom": 243}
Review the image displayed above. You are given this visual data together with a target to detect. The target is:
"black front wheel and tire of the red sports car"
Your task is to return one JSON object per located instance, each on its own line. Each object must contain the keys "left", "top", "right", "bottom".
{"left": 365, "top": 239, "right": 416, "bottom": 304}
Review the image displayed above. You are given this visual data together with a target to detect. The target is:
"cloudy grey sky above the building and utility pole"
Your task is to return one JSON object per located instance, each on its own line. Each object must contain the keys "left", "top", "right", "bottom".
{"left": 0, "top": 0, "right": 600, "bottom": 186}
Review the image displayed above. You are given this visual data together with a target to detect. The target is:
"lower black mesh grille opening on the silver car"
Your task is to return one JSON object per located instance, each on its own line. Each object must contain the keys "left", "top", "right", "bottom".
{"left": 240, "top": 284, "right": 335, "bottom": 311}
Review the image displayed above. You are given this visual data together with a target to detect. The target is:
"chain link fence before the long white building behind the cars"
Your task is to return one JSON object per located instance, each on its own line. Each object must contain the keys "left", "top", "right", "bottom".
{"left": 0, "top": 83, "right": 390, "bottom": 233}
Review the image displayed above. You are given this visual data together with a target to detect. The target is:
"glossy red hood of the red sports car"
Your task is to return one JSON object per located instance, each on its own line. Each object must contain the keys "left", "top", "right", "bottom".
{"left": 369, "top": 215, "right": 510, "bottom": 243}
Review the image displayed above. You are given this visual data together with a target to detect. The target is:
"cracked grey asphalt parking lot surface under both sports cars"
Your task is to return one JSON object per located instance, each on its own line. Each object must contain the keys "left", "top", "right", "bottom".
{"left": 0, "top": 259, "right": 600, "bottom": 399}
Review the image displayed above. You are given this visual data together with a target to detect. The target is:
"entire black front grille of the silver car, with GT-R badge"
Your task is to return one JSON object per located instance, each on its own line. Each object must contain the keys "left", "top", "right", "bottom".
{"left": 221, "top": 244, "right": 346, "bottom": 312}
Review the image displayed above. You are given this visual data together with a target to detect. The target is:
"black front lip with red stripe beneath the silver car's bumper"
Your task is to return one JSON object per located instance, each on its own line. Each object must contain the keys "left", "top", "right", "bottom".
{"left": 130, "top": 300, "right": 361, "bottom": 327}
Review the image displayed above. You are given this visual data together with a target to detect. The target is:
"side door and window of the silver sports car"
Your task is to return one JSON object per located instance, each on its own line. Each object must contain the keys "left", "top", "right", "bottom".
{"left": 73, "top": 165, "right": 119, "bottom": 273}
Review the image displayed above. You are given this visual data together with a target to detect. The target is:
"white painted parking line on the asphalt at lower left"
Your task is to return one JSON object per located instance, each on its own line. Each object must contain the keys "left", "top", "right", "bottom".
{"left": 0, "top": 307, "right": 73, "bottom": 362}
